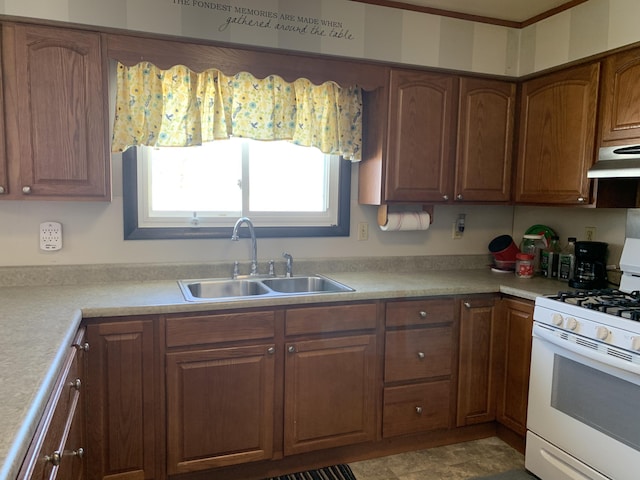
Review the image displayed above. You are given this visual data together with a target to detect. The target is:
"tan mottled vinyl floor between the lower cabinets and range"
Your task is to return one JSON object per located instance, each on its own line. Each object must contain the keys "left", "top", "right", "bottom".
{"left": 349, "top": 437, "right": 524, "bottom": 480}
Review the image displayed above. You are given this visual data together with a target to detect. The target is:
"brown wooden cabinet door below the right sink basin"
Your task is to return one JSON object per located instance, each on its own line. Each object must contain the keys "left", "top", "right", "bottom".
{"left": 284, "top": 335, "right": 377, "bottom": 455}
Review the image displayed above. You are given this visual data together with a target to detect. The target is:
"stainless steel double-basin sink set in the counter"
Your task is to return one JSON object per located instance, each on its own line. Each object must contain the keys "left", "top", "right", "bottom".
{"left": 178, "top": 275, "right": 354, "bottom": 302}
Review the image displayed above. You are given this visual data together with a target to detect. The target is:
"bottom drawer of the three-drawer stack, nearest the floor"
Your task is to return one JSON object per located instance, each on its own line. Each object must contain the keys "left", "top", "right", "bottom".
{"left": 382, "top": 380, "right": 451, "bottom": 438}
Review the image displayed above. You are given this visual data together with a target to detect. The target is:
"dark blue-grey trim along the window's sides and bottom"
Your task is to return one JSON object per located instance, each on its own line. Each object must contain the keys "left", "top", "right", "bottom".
{"left": 122, "top": 147, "right": 351, "bottom": 240}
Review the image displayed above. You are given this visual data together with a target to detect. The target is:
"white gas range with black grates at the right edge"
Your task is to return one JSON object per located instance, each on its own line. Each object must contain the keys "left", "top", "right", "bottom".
{"left": 525, "top": 239, "right": 640, "bottom": 480}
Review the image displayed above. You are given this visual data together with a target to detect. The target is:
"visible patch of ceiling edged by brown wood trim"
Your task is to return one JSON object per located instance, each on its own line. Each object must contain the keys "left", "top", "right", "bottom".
{"left": 356, "top": 0, "right": 586, "bottom": 24}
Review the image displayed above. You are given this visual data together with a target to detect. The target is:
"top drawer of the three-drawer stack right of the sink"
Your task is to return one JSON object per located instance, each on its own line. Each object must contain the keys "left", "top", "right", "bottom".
{"left": 386, "top": 298, "right": 455, "bottom": 327}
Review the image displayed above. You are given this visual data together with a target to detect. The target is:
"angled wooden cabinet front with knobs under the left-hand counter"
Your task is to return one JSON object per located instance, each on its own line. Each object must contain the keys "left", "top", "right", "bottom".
{"left": 19, "top": 329, "right": 84, "bottom": 480}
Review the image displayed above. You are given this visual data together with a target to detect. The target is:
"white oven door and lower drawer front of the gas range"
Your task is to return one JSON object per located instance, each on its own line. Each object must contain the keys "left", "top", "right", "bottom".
{"left": 525, "top": 322, "right": 640, "bottom": 480}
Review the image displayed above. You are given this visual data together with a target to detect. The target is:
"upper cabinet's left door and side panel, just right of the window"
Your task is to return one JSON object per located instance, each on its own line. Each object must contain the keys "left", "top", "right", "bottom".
{"left": 359, "top": 70, "right": 458, "bottom": 205}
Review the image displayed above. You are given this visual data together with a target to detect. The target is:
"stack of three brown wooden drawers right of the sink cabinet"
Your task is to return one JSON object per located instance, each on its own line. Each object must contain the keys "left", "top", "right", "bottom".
{"left": 382, "top": 298, "right": 457, "bottom": 438}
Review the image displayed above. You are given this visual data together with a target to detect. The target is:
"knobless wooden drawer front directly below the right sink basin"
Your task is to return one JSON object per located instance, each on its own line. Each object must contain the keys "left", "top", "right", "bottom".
{"left": 285, "top": 303, "right": 376, "bottom": 335}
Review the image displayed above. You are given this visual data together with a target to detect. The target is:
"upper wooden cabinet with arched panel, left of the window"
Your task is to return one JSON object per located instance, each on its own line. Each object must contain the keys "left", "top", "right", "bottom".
{"left": 0, "top": 24, "right": 111, "bottom": 200}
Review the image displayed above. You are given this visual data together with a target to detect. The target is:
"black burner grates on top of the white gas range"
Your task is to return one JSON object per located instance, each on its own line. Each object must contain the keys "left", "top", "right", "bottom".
{"left": 550, "top": 288, "right": 640, "bottom": 321}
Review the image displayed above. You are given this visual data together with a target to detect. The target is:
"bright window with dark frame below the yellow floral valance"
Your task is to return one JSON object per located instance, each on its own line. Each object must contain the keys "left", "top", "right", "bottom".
{"left": 123, "top": 138, "right": 351, "bottom": 240}
